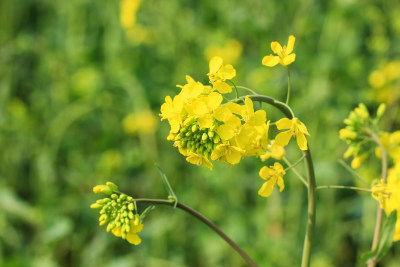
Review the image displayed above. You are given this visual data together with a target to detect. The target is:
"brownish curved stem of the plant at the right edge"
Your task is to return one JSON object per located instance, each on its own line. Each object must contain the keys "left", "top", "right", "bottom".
{"left": 366, "top": 129, "right": 387, "bottom": 267}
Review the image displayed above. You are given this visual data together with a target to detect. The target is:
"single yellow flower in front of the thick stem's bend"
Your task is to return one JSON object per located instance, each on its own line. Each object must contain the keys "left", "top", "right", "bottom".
{"left": 275, "top": 118, "right": 310, "bottom": 150}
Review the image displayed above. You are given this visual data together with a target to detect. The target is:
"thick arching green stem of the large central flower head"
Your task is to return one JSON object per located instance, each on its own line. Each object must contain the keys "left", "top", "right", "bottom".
{"left": 249, "top": 95, "right": 317, "bottom": 267}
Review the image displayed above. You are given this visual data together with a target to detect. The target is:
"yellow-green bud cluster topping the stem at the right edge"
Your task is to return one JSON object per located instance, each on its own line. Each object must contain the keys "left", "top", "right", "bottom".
{"left": 339, "top": 103, "right": 385, "bottom": 169}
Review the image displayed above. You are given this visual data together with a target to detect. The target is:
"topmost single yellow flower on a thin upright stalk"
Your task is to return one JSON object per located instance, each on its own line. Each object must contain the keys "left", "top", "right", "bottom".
{"left": 262, "top": 35, "right": 296, "bottom": 67}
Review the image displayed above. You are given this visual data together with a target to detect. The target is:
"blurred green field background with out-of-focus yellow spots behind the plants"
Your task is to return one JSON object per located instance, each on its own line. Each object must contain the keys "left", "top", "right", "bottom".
{"left": 0, "top": 0, "right": 400, "bottom": 267}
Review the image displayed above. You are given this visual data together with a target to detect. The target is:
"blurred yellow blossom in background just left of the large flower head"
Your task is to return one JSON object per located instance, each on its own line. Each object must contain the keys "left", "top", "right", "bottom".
{"left": 122, "top": 110, "right": 157, "bottom": 134}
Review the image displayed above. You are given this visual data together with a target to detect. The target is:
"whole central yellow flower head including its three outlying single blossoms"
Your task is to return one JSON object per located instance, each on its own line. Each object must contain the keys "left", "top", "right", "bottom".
{"left": 160, "top": 44, "right": 310, "bottom": 197}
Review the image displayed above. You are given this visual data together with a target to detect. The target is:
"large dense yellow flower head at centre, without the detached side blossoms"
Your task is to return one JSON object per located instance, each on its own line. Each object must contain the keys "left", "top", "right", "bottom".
{"left": 160, "top": 57, "right": 269, "bottom": 169}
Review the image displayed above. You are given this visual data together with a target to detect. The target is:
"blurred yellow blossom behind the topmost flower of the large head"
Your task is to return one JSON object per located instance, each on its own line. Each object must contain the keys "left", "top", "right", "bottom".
{"left": 204, "top": 39, "right": 243, "bottom": 64}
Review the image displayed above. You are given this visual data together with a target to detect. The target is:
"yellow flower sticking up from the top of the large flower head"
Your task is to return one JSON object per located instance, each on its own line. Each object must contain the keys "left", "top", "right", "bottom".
{"left": 207, "top": 57, "right": 236, "bottom": 94}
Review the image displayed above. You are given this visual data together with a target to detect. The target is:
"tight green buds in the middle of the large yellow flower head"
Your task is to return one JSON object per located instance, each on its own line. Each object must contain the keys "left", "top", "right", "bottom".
{"left": 174, "top": 117, "right": 221, "bottom": 158}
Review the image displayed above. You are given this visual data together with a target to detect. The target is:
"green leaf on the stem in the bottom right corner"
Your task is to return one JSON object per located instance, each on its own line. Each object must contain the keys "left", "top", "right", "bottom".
{"left": 361, "top": 210, "right": 397, "bottom": 262}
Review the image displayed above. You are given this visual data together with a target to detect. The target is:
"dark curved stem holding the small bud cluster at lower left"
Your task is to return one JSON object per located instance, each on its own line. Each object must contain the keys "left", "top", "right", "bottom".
{"left": 135, "top": 198, "right": 258, "bottom": 267}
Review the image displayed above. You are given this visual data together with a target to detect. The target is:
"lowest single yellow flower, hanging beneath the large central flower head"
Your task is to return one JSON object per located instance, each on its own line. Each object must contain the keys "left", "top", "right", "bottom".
{"left": 258, "top": 162, "right": 286, "bottom": 197}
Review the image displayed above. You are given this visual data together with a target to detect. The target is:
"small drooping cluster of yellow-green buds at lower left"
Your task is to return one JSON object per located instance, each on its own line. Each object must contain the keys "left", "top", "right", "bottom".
{"left": 90, "top": 182, "right": 143, "bottom": 245}
